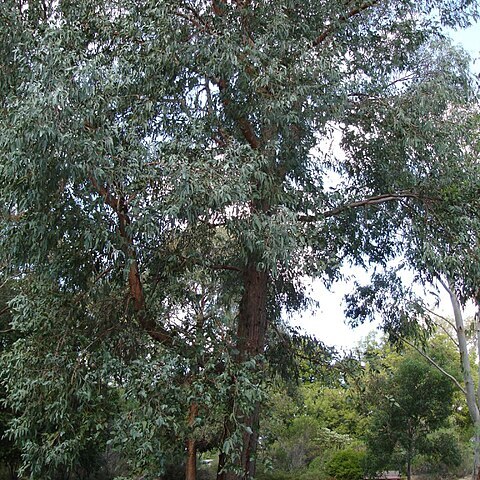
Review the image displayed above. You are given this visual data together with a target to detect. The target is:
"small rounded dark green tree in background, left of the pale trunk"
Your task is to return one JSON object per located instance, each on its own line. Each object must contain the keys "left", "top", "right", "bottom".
{"left": 366, "top": 344, "right": 458, "bottom": 473}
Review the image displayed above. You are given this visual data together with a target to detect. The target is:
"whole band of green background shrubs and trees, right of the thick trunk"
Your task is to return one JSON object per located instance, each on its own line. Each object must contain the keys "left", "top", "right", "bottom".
{"left": 259, "top": 333, "right": 471, "bottom": 480}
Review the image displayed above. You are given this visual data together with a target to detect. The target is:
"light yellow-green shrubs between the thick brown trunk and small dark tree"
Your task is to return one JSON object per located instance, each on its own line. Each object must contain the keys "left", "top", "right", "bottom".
{"left": 261, "top": 359, "right": 363, "bottom": 478}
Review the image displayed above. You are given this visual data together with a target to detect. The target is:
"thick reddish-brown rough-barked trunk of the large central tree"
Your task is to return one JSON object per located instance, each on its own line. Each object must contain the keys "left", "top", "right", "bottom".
{"left": 217, "top": 262, "right": 268, "bottom": 480}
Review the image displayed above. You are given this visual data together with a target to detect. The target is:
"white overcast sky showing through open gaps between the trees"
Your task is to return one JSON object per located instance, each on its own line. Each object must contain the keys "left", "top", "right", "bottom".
{"left": 290, "top": 23, "right": 480, "bottom": 349}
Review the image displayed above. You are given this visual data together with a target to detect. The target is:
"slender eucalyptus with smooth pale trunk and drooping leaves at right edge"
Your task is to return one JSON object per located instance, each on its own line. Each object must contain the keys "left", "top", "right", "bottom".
{"left": 347, "top": 96, "right": 480, "bottom": 478}
